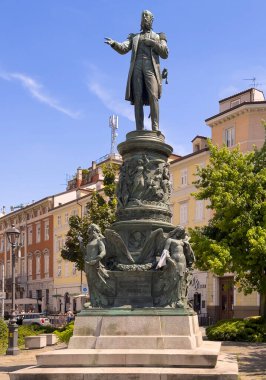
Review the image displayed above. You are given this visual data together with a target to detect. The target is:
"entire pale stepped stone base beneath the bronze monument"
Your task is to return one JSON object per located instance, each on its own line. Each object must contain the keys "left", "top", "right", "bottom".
{"left": 10, "top": 308, "right": 238, "bottom": 380}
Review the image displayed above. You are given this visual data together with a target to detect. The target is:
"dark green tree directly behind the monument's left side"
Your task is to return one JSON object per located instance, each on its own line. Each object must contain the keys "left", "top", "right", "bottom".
{"left": 61, "top": 163, "right": 119, "bottom": 270}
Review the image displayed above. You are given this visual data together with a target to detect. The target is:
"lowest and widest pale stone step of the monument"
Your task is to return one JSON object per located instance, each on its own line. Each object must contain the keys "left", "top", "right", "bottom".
{"left": 9, "top": 355, "right": 238, "bottom": 380}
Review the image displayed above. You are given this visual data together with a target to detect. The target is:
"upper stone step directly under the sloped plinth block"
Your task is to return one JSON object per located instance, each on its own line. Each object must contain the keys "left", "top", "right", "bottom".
{"left": 37, "top": 342, "right": 220, "bottom": 368}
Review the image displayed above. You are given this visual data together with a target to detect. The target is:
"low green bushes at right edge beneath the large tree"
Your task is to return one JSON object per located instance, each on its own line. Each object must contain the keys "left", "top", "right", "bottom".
{"left": 206, "top": 317, "right": 266, "bottom": 342}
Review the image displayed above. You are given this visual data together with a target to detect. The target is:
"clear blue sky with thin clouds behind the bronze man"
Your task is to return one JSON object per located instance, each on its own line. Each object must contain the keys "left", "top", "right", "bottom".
{"left": 0, "top": 0, "right": 266, "bottom": 210}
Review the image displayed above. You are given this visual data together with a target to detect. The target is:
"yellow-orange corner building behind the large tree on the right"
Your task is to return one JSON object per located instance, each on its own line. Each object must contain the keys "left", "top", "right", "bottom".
{"left": 170, "top": 88, "right": 266, "bottom": 319}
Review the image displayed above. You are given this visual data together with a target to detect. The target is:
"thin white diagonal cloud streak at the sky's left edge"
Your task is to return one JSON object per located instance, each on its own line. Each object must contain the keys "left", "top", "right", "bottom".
{"left": 0, "top": 71, "right": 80, "bottom": 119}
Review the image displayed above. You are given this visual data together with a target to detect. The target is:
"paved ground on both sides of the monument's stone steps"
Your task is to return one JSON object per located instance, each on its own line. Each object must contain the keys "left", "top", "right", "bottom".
{"left": 0, "top": 342, "right": 266, "bottom": 380}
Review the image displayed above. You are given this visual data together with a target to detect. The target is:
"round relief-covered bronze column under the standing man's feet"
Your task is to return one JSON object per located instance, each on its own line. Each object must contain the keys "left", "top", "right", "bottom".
{"left": 112, "top": 131, "right": 173, "bottom": 260}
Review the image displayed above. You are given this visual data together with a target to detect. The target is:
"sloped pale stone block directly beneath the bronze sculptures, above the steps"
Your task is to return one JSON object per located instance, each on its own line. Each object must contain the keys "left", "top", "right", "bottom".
{"left": 69, "top": 308, "right": 202, "bottom": 350}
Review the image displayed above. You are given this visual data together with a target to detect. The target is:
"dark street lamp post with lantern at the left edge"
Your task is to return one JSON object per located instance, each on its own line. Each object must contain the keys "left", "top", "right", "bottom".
{"left": 6, "top": 224, "right": 20, "bottom": 355}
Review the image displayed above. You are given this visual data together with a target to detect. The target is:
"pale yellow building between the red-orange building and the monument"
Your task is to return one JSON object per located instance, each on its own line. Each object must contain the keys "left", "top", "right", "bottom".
{"left": 52, "top": 154, "right": 122, "bottom": 313}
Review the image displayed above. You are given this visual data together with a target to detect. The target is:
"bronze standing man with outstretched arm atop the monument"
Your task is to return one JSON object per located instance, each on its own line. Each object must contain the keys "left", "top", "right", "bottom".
{"left": 105, "top": 10, "right": 168, "bottom": 131}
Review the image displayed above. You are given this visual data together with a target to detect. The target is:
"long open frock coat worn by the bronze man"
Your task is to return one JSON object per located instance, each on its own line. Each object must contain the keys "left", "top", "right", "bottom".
{"left": 112, "top": 31, "right": 168, "bottom": 105}
